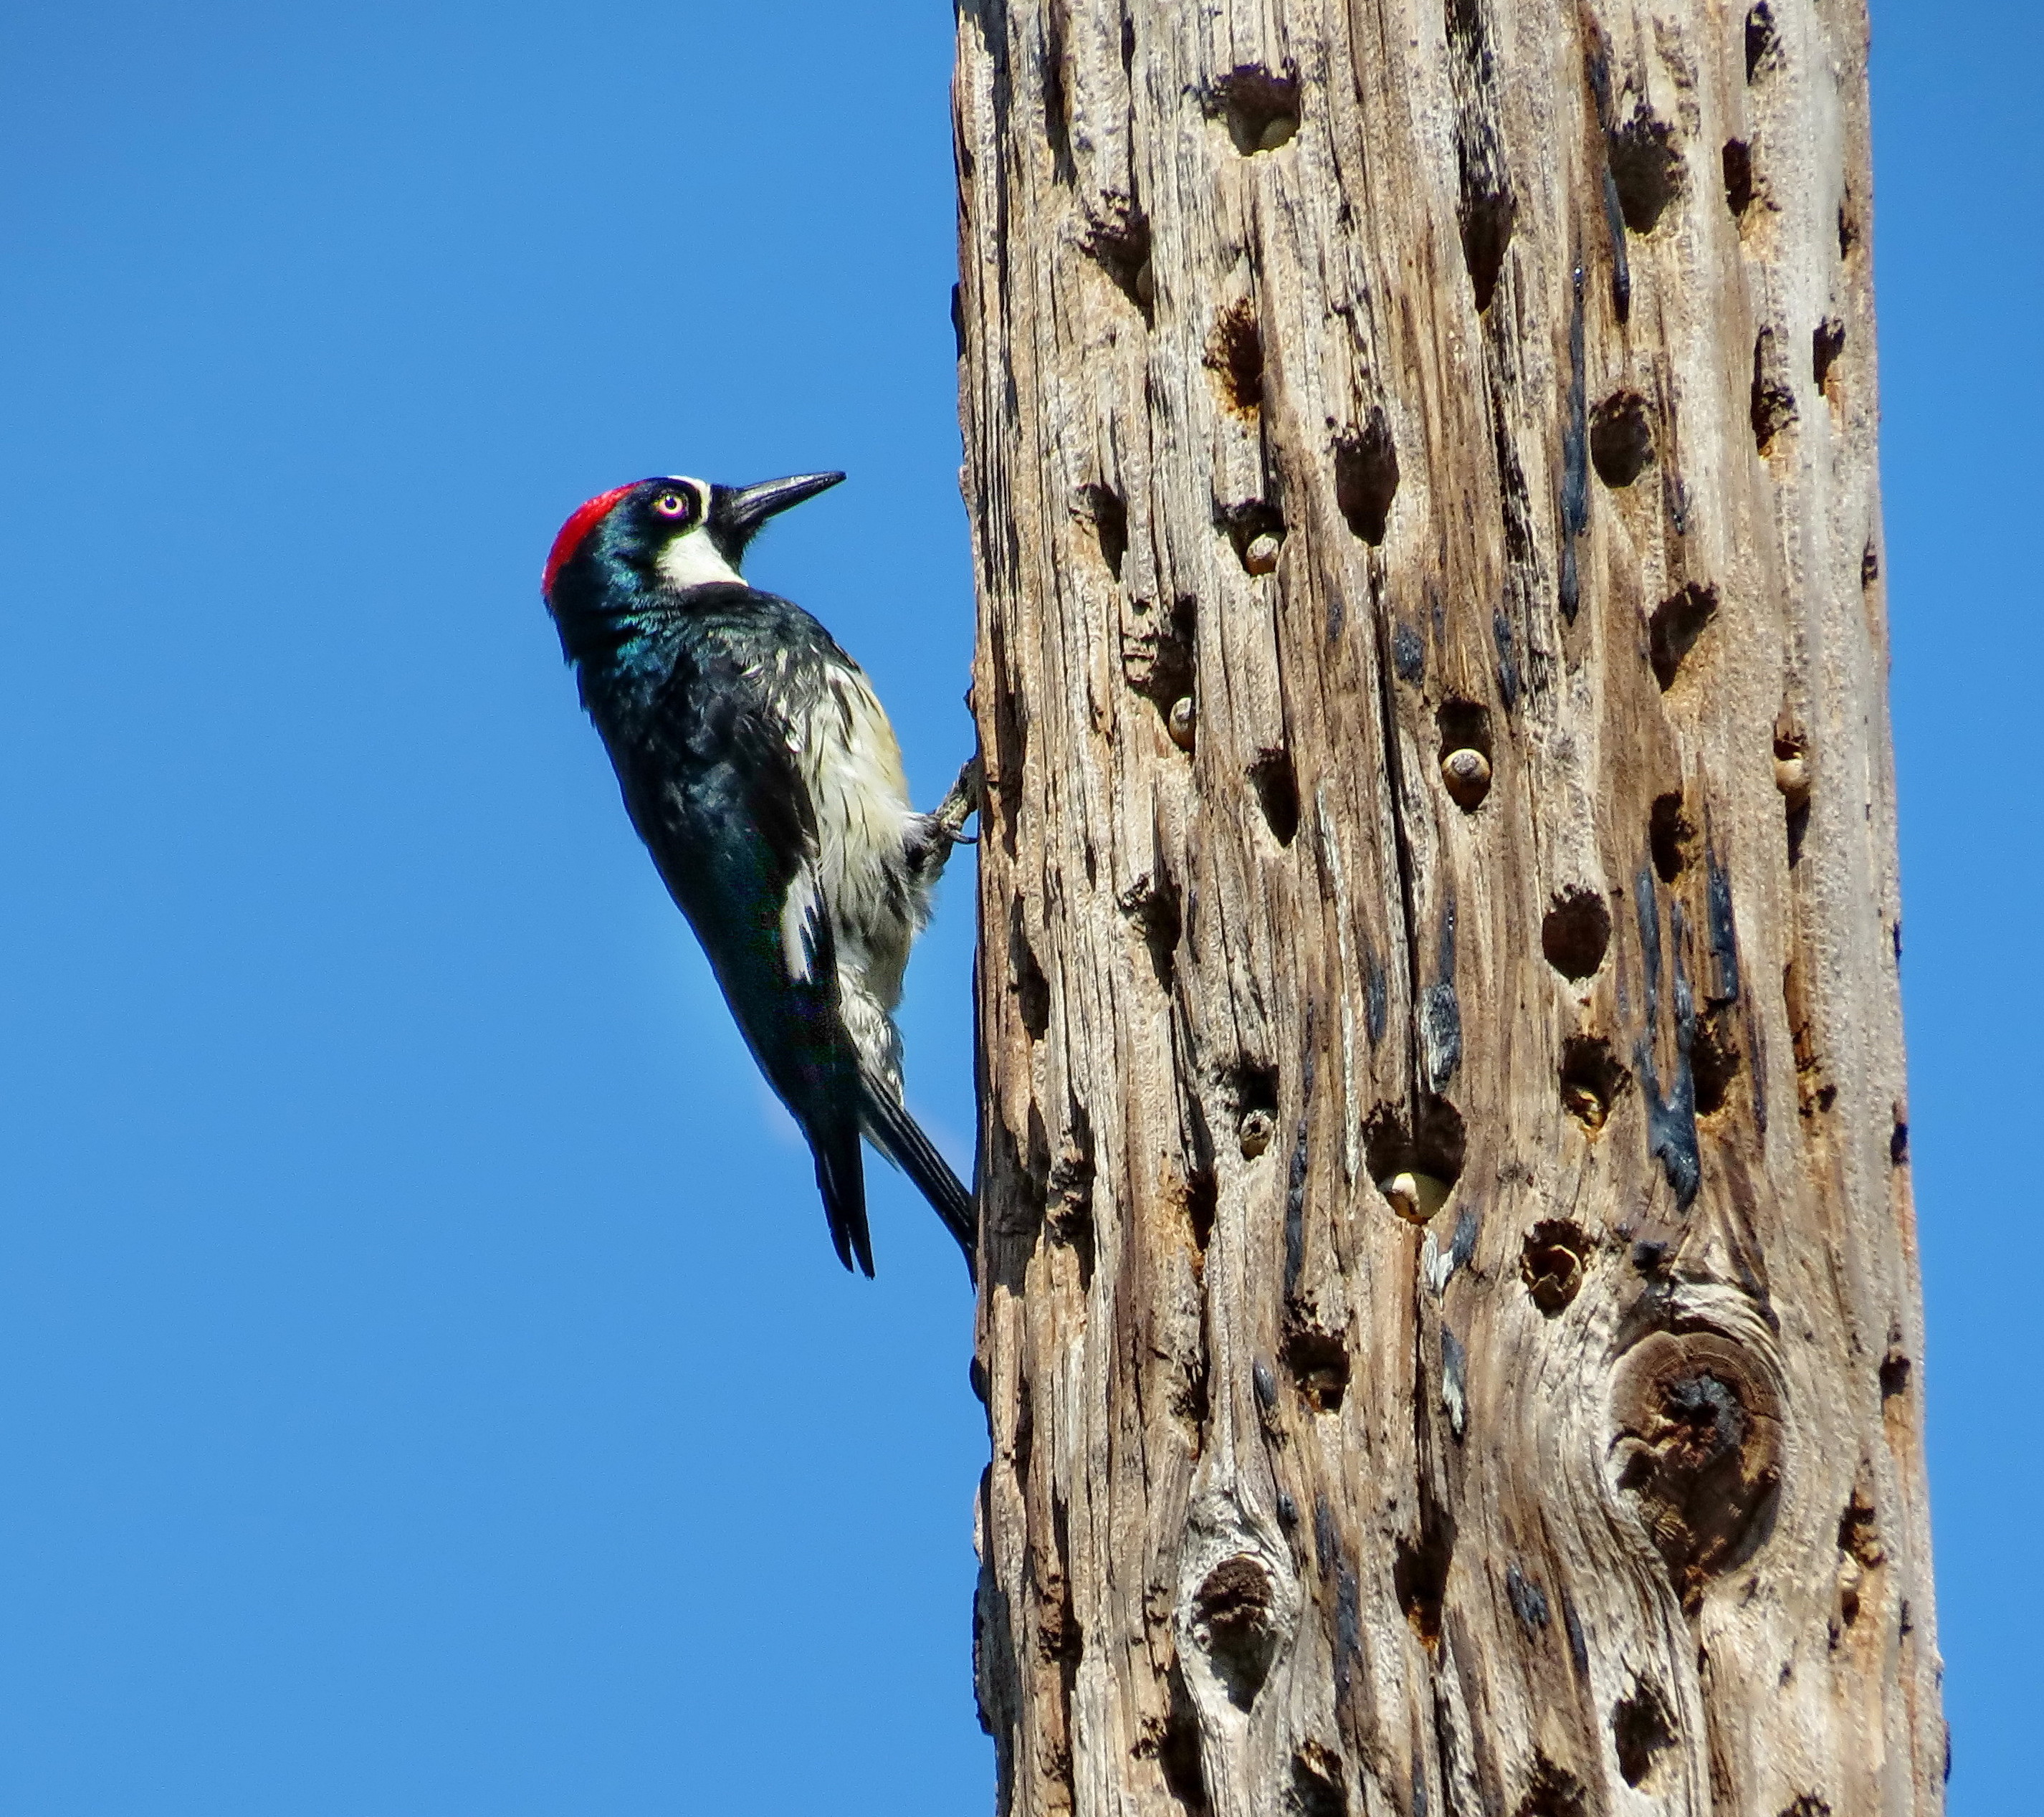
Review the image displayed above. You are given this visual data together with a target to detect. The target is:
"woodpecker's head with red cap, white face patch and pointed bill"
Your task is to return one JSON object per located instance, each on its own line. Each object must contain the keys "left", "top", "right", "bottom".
{"left": 540, "top": 474, "right": 844, "bottom": 656}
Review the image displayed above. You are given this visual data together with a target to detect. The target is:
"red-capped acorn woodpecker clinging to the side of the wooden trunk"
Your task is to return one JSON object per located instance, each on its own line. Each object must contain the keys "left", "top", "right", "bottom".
{"left": 542, "top": 474, "right": 979, "bottom": 1275}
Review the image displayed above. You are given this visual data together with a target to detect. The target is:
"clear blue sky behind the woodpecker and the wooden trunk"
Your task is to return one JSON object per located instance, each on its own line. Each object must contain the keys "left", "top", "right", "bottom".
{"left": 0, "top": 0, "right": 2044, "bottom": 1817}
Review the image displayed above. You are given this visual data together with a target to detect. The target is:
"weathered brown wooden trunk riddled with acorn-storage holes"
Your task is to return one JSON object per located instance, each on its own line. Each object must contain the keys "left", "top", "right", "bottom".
{"left": 957, "top": 0, "right": 1944, "bottom": 1817}
